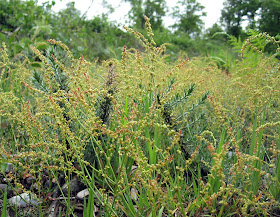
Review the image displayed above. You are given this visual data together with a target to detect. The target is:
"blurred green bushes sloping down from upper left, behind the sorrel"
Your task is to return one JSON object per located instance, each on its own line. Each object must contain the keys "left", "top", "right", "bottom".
{"left": 0, "top": 0, "right": 135, "bottom": 60}
